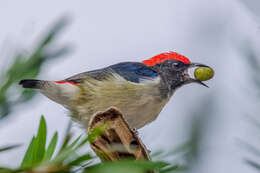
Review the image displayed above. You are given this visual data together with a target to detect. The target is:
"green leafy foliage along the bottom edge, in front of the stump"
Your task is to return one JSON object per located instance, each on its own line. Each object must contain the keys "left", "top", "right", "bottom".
{"left": 0, "top": 117, "right": 187, "bottom": 173}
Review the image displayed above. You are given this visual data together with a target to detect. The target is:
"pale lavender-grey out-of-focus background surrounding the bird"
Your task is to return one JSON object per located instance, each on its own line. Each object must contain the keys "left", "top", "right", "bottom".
{"left": 0, "top": 0, "right": 260, "bottom": 173}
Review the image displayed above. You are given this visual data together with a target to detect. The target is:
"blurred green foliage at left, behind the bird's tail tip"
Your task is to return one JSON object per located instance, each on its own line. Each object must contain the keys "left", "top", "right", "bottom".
{"left": 0, "top": 18, "right": 69, "bottom": 119}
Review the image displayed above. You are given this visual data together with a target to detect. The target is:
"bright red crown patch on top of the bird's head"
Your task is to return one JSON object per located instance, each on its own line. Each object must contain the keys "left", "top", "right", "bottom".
{"left": 142, "top": 52, "right": 190, "bottom": 66}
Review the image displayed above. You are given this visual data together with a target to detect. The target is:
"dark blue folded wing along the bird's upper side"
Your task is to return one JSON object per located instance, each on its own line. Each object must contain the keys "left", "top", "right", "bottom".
{"left": 65, "top": 62, "right": 158, "bottom": 83}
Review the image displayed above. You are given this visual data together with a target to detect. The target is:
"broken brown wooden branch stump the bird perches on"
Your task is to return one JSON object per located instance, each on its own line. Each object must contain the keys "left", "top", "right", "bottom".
{"left": 88, "top": 107, "right": 150, "bottom": 161}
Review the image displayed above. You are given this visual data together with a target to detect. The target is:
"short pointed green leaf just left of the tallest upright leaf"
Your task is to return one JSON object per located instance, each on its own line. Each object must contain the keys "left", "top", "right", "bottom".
{"left": 21, "top": 136, "right": 35, "bottom": 168}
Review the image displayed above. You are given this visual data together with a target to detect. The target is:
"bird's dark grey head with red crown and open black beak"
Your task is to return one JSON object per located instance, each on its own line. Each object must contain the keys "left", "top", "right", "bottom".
{"left": 142, "top": 52, "right": 208, "bottom": 90}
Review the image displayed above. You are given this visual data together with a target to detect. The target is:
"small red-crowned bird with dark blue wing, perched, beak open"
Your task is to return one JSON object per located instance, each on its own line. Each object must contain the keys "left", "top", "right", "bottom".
{"left": 19, "top": 51, "right": 209, "bottom": 129}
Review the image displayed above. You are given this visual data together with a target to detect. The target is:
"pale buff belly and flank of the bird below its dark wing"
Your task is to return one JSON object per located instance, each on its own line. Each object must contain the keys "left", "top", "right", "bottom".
{"left": 71, "top": 76, "right": 168, "bottom": 128}
